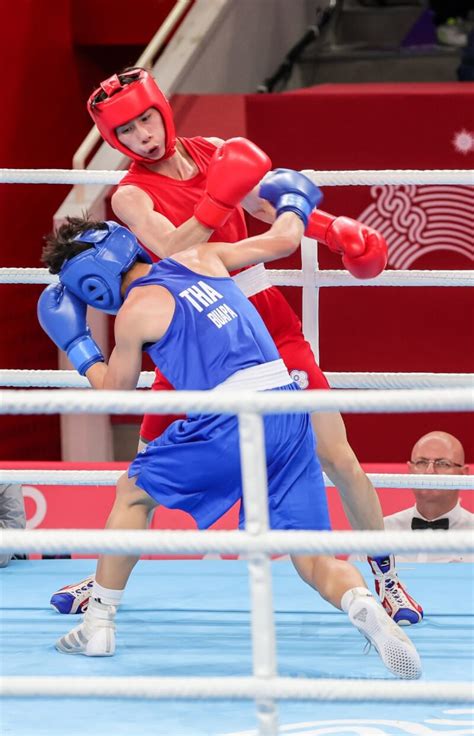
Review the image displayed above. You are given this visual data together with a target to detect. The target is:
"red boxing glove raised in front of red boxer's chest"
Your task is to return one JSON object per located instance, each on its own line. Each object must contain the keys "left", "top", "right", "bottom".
{"left": 194, "top": 138, "right": 272, "bottom": 230}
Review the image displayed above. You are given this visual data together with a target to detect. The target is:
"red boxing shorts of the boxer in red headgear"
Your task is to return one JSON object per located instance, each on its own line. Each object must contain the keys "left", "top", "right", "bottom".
{"left": 140, "top": 332, "right": 329, "bottom": 442}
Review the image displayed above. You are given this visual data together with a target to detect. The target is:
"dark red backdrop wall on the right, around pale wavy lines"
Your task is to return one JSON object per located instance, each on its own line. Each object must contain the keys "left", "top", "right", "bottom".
{"left": 247, "top": 83, "right": 474, "bottom": 462}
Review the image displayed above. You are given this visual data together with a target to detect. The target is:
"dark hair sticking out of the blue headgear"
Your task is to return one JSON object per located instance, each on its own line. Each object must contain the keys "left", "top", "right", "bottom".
{"left": 41, "top": 217, "right": 107, "bottom": 273}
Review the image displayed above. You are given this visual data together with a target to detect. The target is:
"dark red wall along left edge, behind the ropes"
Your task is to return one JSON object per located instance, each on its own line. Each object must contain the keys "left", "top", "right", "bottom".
{"left": 0, "top": 0, "right": 88, "bottom": 459}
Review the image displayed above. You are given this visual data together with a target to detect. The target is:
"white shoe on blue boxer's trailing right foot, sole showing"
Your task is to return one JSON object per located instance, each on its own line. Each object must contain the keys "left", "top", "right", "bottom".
{"left": 348, "top": 595, "right": 421, "bottom": 680}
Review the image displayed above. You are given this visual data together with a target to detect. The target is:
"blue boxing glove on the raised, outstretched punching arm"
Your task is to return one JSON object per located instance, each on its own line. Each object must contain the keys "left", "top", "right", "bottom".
{"left": 259, "top": 169, "right": 323, "bottom": 227}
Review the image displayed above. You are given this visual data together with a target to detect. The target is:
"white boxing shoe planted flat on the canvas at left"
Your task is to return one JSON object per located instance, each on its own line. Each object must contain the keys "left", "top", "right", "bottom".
{"left": 55, "top": 599, "right": 116, "bottom": 657}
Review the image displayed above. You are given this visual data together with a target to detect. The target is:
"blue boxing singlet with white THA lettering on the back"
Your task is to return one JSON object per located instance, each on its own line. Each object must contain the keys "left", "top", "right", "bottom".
{"left": 125, "top": 258, "right": 280, "bottom": 390}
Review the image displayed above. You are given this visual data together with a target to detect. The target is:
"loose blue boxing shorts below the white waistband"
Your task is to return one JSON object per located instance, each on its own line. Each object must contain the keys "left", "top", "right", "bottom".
{"left": 128, "top": 384, "right": 331, "bottom": 530}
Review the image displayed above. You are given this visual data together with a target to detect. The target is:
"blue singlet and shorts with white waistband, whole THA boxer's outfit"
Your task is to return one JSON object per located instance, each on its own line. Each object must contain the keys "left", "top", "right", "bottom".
{"left": 126, "top": 258, "right": 329, "bottom": 529}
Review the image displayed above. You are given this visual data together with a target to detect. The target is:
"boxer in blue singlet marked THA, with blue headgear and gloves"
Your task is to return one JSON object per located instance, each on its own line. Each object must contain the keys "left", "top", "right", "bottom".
{"left": 38, "top": 144, "right": 421, "bottom": 679}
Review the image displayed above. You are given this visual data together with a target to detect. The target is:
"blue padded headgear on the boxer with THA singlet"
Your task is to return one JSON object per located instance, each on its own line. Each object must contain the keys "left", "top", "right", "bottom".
{"left": 59, "top": 220, "right": 152, "bottom": 314}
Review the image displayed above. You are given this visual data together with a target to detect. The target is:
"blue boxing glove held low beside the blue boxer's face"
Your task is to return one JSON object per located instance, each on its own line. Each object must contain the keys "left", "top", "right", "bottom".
{"left": 37, "top": 284, "right": 104, "bottom": 376}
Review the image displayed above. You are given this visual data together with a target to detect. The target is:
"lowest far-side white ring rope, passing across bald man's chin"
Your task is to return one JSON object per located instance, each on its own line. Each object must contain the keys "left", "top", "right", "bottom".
{"left": 0, "top": 468, "right": 474, "bottom": 491}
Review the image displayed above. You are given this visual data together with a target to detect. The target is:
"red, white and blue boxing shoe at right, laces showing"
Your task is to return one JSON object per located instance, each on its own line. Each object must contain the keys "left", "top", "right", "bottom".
{"left": 367, "top": 555, "right": 423, "bottom": 626}
